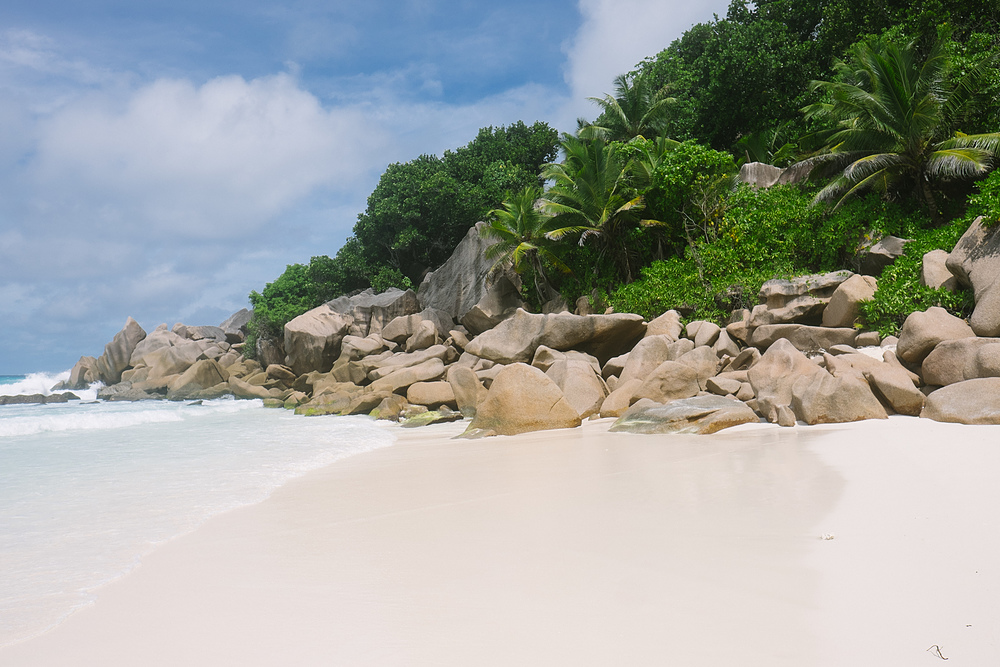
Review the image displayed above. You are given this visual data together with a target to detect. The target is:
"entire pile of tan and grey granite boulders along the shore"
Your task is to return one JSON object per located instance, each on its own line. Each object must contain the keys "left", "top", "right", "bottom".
{"left": 64, "top": 214, "right": 1000, "bottom": 437}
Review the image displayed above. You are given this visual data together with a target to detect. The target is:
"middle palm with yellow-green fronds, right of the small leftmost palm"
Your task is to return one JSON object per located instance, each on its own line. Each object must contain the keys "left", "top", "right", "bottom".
{"left": 542, "top": 134, "right": 658, "bottom": 282}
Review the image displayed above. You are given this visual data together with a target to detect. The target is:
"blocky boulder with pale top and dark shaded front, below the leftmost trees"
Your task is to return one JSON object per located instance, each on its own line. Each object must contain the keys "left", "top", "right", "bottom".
{"left": 284, "top": 303, "right": 353, "bottom": 375}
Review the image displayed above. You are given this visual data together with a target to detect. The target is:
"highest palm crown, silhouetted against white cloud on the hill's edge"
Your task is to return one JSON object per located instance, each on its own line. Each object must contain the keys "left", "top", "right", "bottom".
{"left": 577, "top": 73, "right": 676, "bottom": 141}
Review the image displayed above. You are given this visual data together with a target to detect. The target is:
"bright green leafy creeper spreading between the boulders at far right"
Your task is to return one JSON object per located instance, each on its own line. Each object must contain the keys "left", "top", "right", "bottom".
{"left": 861, "top": 218, "right": 975, "bottom": 336}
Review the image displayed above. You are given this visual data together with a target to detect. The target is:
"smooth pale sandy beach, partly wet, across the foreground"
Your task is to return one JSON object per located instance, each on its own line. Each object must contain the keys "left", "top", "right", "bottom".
{"left": 0, "top": 417, "right": 1000, "bottom": 667}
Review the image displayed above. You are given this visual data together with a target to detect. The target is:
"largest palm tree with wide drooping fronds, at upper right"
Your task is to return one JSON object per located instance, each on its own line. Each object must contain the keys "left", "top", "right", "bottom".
{"left": 803, "top": 38, "right": 1000, "bottom": 220}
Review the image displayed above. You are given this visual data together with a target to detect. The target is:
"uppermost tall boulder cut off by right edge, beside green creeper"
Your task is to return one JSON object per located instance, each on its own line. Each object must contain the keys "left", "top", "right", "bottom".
{"left": 947, "top": 217, "right": 1000, "bottom": 336}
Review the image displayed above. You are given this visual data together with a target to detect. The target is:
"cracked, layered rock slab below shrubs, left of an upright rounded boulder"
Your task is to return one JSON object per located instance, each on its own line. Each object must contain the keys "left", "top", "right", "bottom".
{"left": 752, "top": 271, "right": 854, "bottom": 326}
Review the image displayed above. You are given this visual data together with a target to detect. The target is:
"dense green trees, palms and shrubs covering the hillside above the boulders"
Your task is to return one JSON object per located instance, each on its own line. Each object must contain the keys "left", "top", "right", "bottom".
{"left": 244, "top": 0, "right": 1000, "bottom": 360}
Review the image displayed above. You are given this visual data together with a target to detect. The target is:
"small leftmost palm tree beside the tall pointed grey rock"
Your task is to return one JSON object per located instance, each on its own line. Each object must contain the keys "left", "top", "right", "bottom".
{"left": 479, "top": 186, "right": 570, "bottom": 304}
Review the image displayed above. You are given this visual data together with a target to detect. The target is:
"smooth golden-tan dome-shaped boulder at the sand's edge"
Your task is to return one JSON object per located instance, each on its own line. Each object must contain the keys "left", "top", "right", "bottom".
{"left": 469, "top": 362, "right": 593, "bottom": 435}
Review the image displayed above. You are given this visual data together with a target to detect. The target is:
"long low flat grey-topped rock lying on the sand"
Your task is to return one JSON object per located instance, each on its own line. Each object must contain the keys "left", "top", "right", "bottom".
{"left": 609, "top": 396, "right": 760, "bottom": 435}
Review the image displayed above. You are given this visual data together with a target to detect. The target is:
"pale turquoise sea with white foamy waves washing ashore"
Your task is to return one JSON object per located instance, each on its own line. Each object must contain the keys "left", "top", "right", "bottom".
{"left": 0, "top": 372, "right": 393, "bottom": 646}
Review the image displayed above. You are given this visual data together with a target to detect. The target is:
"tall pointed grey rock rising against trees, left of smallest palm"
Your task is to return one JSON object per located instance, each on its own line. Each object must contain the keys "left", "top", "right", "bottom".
{"left": 417, "top": 222, "right": 509, "bottom": 324}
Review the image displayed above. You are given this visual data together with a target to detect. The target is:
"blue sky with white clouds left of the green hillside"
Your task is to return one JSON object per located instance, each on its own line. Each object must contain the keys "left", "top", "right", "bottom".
{"left": 0, "top": 0, "right": 728, "bottom": 374}
